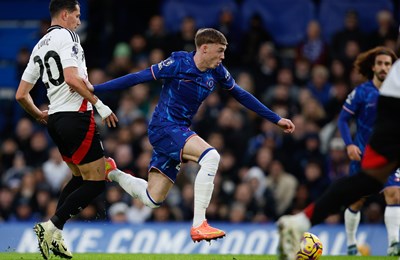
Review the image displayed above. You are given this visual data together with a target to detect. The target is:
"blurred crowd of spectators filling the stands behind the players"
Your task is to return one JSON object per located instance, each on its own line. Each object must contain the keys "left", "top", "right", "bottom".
{"left": 0, "top": 1, "right": 398, "bottom": 223}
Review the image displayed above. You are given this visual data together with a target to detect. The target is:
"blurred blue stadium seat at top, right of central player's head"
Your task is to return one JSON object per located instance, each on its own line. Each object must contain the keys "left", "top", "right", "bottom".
{"left": 241, "top": 0, "right": 315, "bottom": 46}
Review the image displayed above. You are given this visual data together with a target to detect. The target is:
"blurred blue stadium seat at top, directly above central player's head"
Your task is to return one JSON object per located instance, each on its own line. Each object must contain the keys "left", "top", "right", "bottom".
{"left": 161, "top": 0, "right": 238, "bottom": 32}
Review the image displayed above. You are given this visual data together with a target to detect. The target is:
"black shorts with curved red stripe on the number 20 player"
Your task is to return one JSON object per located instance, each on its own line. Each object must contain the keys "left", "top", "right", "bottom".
{"left": 47, "top": 111, "right": 104, "bottom": 164}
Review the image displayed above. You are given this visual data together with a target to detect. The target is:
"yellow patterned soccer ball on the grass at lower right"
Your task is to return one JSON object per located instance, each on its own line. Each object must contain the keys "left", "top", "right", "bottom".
{"left": 296, "top": 232, "right": 322, "bottom": 260}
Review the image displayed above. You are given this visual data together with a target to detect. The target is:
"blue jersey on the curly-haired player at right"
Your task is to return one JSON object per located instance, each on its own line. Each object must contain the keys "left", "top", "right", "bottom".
{"left": 343, "top": 81, "right": 379, "bottom": 152}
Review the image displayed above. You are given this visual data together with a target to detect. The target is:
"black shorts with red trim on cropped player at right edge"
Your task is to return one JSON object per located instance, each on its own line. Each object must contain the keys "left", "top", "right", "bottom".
{"left": 362, "top": 96, "right": 400, "bottom": 169}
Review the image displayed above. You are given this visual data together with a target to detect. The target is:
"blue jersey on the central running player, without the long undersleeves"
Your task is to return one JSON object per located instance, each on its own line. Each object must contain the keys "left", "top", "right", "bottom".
{"left": 150, "top": 51, "right": 235, "bottom": 126}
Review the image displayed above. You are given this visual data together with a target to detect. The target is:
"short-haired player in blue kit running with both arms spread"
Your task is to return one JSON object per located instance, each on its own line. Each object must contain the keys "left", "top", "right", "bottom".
{"left": 87, "top": 28, "right": 295, "bottom": 242}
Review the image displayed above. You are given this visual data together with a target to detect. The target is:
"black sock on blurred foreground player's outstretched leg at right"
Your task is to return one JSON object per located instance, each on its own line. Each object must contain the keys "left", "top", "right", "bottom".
{"left": 311, "top": 172, "right": 383, "bottom": 226}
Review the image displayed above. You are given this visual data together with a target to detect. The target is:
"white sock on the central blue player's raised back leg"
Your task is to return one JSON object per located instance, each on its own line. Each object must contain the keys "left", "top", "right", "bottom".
{"left": 108, "top": 169, "right": 160, "bottom": 208}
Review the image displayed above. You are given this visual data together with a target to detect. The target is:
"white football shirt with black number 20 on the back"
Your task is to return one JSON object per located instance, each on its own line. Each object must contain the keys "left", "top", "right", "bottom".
{"left": 22, "top": 25, "right": 92, "bottom": 114}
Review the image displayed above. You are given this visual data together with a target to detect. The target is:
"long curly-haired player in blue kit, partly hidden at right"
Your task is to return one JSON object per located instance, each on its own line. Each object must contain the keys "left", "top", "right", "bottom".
{"left": 338, "top": 47, "right": 400, "bottom": 255}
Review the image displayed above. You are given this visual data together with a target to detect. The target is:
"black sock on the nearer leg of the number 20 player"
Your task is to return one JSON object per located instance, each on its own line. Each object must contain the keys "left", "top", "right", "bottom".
{"left": 51, "top": 181, "right": 106, "bottom": 229}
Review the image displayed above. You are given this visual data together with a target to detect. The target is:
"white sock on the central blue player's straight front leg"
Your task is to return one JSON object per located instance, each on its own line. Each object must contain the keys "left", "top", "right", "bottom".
{"left": 193, "top": 149, "right": 220, "bottom": 227}
